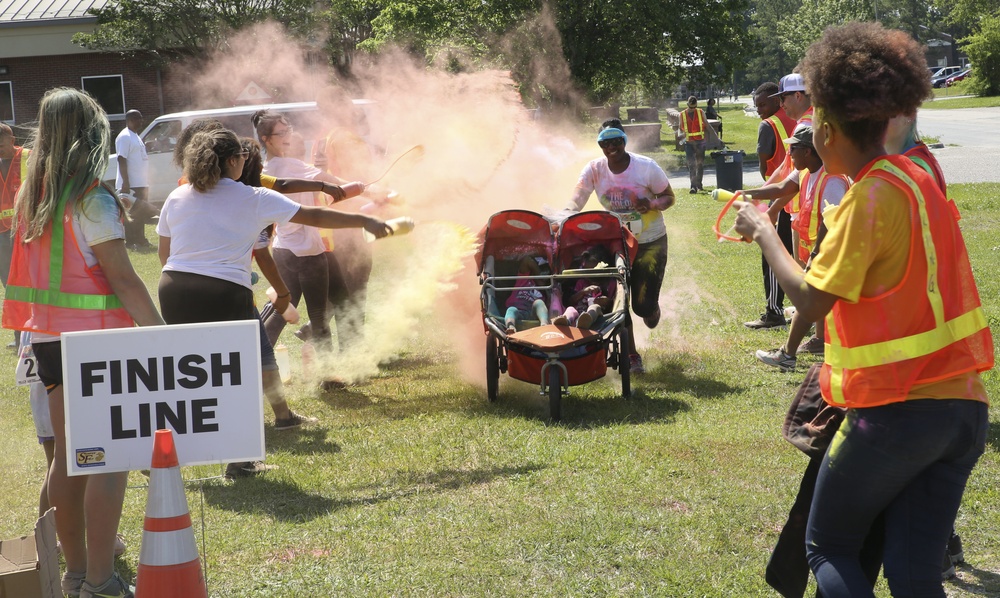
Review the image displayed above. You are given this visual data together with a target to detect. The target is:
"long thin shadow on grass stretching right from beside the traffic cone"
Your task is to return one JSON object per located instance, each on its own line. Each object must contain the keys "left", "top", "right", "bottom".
{"left": 204, "top": 464, "right": 545, "bottom": 522}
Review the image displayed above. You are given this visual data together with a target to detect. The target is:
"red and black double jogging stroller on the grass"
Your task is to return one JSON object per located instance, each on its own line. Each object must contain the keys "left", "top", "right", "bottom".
{"left": 476, "top": 210, "right": 637, "bottom": 420}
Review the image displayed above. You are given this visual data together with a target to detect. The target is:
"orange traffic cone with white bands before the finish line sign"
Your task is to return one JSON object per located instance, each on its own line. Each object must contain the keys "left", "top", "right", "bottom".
{"left": 135, "top": 430, "right": 208, "bottom": 598}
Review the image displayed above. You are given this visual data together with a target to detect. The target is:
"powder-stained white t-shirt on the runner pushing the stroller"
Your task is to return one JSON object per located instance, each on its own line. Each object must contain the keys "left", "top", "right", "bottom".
{"left": 569, "top": 153, "right": 670, "bottom": 243}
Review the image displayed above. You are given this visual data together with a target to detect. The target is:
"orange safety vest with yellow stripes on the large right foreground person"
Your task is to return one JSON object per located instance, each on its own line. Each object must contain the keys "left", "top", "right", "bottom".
{"left": 820, "top": 155, "right": 993, "bottom": 407}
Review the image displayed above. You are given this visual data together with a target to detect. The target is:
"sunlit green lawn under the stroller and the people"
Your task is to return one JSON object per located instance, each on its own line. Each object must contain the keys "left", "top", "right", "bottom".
{"left": 0, "top": 185, "right": 1000, "bottom": 598}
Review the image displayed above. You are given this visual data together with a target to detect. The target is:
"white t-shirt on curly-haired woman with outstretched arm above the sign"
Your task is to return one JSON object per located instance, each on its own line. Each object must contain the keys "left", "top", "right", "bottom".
{"left": 156, "top": 178, "right": 300, "bottom": 288}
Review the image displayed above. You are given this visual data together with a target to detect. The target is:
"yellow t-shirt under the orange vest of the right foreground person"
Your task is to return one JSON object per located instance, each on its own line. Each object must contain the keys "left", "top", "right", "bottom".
{"left": 805, "top": 177, "right": 988, "bottom": 401}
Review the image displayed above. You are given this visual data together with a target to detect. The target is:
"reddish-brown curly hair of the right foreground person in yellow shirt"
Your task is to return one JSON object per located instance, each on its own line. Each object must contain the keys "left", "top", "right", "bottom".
{"left": 801, "top": 22, "right": 931, "bottom": 149}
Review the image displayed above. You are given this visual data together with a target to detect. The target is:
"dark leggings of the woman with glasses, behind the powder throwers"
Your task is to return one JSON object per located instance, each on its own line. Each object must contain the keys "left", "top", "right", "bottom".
{"left": 264, "top": 249, "right": 332, "bottom": 351}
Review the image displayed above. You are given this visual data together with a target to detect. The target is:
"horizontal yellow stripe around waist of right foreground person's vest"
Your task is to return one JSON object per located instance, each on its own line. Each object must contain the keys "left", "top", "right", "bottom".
{"left": 825, "top": 307, "right": 987, "bottom": 370}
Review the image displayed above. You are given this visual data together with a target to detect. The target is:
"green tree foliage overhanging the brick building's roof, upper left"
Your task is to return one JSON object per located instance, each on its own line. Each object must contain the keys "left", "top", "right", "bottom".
{"left": 73, "top": 0, "right": 315, "bottom": 61}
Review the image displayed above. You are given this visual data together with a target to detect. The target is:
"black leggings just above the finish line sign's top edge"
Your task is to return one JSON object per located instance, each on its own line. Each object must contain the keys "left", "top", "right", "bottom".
{"left": 159, "top": 270, "right": 254, "bottom": 324}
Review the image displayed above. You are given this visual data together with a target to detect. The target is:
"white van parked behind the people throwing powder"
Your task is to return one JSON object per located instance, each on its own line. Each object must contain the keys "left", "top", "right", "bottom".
{"left": 103, "top": 100, "right": 374, "bottom": 208}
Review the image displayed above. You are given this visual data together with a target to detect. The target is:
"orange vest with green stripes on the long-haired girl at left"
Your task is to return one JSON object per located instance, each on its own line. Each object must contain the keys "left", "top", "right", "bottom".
{"left": 3, "top": 180, "right": 133, "bottom": 334}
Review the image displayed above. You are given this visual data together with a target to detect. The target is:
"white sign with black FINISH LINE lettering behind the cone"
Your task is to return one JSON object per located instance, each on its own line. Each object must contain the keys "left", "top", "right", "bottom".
{"left": 61, "top": 320, "right": 264, "bottom": 475}
